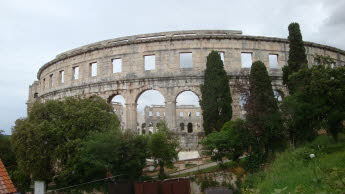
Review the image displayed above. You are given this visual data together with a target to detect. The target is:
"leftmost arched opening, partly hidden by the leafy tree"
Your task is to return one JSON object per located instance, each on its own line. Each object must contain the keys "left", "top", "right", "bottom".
{"left": 108, "top": 95, "right": 126, "bottom": 130}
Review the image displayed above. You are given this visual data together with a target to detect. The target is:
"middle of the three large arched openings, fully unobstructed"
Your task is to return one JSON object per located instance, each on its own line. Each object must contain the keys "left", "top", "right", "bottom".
{"left": 137, "top": 90, "right": 165, "bottom": 133}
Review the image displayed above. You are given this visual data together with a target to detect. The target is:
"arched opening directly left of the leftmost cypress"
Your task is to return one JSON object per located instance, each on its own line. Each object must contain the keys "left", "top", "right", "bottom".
{"left": 176, "top": 91, "right": 202, "bottom": 133}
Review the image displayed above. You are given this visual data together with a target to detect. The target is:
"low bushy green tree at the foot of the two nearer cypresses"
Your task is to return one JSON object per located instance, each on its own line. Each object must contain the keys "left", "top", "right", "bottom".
{"left": 202, "top": 119, "right": 253, "bottom": 164}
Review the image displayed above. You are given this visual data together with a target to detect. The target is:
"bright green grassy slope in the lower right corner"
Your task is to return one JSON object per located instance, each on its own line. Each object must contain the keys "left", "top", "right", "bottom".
{"left": 244, "top": 135, "right": 345, "bottom": 193}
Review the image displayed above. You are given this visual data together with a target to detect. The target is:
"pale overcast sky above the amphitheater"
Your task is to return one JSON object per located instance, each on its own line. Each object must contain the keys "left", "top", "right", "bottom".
{"left": 0, "top": 0, "right": 345, "bottom": 134}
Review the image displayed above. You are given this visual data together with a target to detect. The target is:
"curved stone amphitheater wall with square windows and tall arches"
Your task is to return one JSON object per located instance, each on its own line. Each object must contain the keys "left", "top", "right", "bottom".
{"left": 28, "top": 30, "right": 345, "bottom": 149}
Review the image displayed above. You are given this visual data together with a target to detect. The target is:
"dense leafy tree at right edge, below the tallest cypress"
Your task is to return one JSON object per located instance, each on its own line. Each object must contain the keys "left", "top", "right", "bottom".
{"left": 282, "top": 61, "right": 345, "bottom": 144}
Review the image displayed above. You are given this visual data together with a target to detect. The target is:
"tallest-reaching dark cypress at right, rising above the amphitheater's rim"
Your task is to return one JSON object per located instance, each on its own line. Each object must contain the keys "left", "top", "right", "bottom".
{"left": 283, "top": 23, "right": 308, "bottom": 93}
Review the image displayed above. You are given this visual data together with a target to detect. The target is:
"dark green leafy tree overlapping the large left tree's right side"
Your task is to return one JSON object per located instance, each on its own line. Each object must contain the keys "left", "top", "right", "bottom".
{"left": 56, "top": 131, "right": 149, "bottom": 185}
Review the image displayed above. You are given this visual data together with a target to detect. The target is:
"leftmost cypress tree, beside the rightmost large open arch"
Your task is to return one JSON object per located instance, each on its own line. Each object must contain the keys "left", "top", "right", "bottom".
{"left": 200, "top": 51, "right": 232, "bottom": 135}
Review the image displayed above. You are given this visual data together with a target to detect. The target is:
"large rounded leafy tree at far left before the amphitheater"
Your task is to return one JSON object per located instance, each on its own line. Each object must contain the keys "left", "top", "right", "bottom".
{"left": 12, "top": 96, "right": 119, "bottom": 182}
